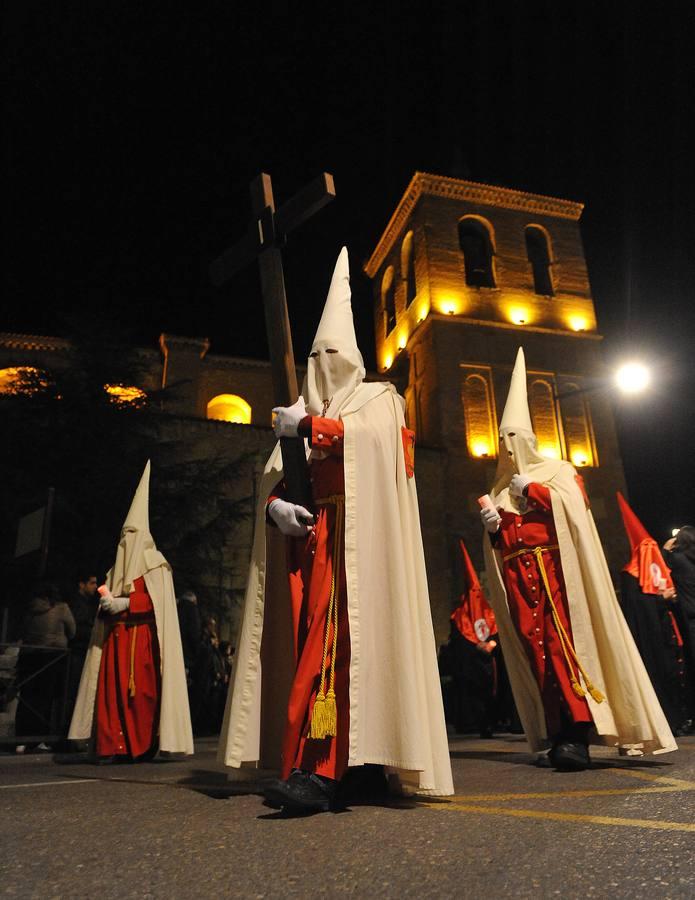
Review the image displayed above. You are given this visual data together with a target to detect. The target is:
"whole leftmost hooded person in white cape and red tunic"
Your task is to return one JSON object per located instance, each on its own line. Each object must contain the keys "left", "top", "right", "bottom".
{"left": 68, "top": 462, "right": 193, "bottom": 761}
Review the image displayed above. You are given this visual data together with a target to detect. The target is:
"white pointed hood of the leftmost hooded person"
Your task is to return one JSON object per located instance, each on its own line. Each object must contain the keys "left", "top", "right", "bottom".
{"left": 106, "top": 460, "right": 169, "bottom": 597}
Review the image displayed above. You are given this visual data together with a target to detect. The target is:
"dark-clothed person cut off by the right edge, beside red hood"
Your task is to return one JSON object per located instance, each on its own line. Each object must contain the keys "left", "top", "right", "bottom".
{"left": 663, "top": 525, "right": 695, "bottom": 734}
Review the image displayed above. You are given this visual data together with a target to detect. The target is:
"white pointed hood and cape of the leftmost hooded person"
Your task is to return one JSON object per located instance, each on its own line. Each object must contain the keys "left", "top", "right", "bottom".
{"left": 68, "top": 461, "right": 193, "bottom": 755}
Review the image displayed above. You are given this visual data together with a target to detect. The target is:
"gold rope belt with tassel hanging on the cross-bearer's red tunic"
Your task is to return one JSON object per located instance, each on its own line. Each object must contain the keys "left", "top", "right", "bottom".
{"left": 309, "top": 494, "right": 345, "bottom": 741}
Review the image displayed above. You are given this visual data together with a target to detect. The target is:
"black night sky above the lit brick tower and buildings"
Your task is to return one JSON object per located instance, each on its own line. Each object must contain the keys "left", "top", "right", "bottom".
{"left": 5, "top": 0, "right": 695, "bottom": 539}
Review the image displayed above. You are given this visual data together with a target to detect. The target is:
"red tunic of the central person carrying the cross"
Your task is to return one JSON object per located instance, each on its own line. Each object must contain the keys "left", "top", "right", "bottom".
{"left": 274, "top": 416, "right": 350, "bottom": 779}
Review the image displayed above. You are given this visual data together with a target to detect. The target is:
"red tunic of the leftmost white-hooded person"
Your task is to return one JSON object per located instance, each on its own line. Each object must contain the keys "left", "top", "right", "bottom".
{"left": 96, "top": 578, "right": 161, "bottom": 759}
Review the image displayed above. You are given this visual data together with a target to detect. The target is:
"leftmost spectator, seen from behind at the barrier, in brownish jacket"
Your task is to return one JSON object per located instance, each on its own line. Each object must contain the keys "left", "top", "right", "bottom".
{"left": 15, "top": 582, "right": 76, "bottom": 753}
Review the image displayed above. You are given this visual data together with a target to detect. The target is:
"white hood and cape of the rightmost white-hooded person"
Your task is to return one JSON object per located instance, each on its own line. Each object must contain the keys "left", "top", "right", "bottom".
{"left": 481, "top": 348, "right": 676, "bottom": 754}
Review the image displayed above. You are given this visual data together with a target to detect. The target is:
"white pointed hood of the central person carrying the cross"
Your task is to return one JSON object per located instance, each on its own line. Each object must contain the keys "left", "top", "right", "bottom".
{"left": 302, "top": 247, "right": 365, "bottom": 419}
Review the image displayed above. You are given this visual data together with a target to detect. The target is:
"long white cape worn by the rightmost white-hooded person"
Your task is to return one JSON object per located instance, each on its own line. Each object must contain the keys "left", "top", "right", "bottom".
{"left": 484, "top": 463, "right": 677, "bottom": 753}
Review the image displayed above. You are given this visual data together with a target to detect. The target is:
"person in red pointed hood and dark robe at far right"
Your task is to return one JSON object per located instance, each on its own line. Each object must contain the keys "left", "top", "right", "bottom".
{"left": 617, "top": 491, "right": 689, "bottom": 735}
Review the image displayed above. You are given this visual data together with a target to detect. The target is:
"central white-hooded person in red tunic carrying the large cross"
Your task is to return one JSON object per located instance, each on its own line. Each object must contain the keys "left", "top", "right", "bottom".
{"left": 219, "top": 248, "right": 453, "bottom": 810}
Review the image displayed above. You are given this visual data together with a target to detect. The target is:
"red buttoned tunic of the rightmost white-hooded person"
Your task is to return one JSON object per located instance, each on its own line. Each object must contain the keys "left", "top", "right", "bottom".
{"left": 495, "top": 483, "right": 593, "bottom": 737}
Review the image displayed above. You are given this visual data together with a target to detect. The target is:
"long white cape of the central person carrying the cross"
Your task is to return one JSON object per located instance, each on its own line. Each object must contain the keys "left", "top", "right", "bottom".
{"left": 218, "top": 384, "right": 453, "bottom": 796}
